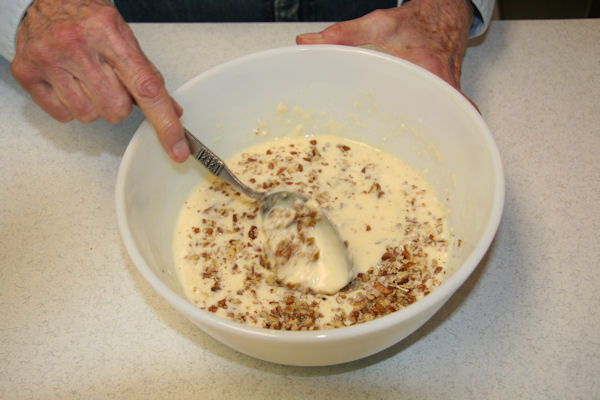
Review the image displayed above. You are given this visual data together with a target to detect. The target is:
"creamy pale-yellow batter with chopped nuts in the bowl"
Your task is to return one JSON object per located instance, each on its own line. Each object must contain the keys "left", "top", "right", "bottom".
{"left": 174, "top": 136, "right": 450, "bottom": 330}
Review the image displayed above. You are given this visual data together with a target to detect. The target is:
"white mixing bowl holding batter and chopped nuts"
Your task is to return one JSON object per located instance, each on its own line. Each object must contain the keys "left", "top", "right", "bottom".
{"left": 116, "top": 46, "right": 504, "bottom": 365}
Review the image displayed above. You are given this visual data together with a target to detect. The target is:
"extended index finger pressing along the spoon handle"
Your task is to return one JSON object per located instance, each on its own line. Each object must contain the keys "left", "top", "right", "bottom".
{"left": 107, "top": 25, "right": 190, "bottom": 162}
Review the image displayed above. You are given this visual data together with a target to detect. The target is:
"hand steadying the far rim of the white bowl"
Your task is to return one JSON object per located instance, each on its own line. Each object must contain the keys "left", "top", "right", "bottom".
{"left": 296, "top": 0, "right": 473, "bottom": 91}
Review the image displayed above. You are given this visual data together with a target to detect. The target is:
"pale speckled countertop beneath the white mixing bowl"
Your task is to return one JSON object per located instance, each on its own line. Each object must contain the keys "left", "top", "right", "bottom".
{"left": 0, "top": 20, "right": 600, "bottom": 399}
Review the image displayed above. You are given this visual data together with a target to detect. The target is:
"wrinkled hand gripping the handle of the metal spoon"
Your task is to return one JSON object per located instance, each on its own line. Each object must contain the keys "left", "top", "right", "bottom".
{"left": 10, "top": 0, "right": 189, "bottom": 161}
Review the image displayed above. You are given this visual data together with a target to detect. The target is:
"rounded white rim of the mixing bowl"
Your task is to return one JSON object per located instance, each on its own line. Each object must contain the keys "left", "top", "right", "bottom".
{"left": 115, "top": 45, "right": 505, "bottom": 343}
